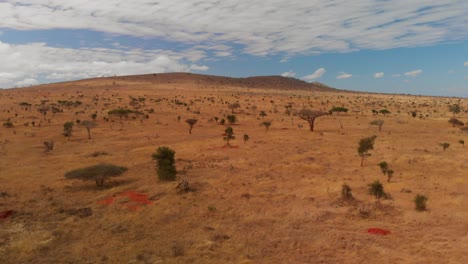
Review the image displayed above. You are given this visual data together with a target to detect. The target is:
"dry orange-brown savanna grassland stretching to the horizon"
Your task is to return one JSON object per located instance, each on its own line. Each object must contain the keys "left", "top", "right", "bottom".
{"left": 0, "top": 72, "right": 468, "bottom": 263}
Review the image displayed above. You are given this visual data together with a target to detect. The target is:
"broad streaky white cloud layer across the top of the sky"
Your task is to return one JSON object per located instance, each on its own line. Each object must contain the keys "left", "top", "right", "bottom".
{"left": 0, "top": 0, "right": 468, "bottom": 56}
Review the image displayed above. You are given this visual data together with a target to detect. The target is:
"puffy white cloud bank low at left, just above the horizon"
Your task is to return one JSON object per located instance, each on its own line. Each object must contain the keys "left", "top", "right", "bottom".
{"left": 0, "top": 41, "right": 208, "bottom": 87}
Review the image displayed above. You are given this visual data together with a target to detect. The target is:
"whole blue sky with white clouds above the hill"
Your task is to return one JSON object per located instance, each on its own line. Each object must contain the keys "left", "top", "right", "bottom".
{"left": 0, "top": 0, "right": 468, "bottom": 97}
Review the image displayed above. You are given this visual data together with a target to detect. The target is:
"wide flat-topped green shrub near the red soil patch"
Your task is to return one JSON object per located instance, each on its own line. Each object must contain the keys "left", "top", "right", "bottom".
{"left": 65, "top": 164, "right": 127, "bottom": 186}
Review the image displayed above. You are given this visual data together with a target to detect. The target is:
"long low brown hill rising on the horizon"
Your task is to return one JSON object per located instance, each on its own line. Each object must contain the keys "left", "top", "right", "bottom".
{"left": 83, "top": 72, "right": 342, "bottom": 92}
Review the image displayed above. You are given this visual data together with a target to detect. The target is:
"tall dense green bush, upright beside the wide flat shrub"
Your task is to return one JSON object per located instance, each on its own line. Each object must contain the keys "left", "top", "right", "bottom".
{"left": 152, "top": 147, "right": 177, "bottom": 181}
